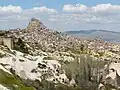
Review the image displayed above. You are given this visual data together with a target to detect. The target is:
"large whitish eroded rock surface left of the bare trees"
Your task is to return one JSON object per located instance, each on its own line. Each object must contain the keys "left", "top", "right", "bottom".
{"left": 0, "top": 50, "right": 69, "bottom": 83}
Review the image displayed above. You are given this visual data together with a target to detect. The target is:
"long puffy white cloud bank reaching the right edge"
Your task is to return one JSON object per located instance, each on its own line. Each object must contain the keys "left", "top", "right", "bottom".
{"left": 63, "top": 3, "right": 120, "bottom": 14}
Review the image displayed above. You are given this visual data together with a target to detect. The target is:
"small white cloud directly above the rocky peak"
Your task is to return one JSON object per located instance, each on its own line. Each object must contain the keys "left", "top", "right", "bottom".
{"left": 32, "top": 6, "right": 57, "bottom": 13}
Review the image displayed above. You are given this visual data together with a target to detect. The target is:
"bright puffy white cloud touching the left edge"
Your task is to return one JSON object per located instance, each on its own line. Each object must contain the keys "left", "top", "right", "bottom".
{"left": 0, "top": 5, "right": 23, "bottom": 13}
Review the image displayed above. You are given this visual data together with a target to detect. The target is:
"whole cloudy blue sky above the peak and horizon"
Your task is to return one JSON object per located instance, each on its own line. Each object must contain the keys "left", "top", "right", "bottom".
{"left": 0, "top": 0, "right": 120, "bottom": 31}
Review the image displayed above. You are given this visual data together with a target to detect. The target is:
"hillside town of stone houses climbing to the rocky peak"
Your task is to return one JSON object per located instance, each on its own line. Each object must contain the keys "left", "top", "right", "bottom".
{"left": 0, "top": 18, "right": 120, "bottom": 63}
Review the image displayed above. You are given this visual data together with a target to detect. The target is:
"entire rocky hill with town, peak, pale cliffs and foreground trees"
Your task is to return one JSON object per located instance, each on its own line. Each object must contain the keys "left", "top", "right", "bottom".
{"left": 0, "top": 18, "right": 120, "bottom": 90}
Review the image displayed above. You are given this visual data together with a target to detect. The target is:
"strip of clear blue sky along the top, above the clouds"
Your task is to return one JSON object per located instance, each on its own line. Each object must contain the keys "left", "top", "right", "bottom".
{"left": 0, "top": 0, "right": 120, "bottom": 10}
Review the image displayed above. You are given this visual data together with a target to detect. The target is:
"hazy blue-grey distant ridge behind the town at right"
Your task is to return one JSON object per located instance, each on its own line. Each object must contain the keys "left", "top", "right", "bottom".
{"left": 65, "top": 30, "right": 120, "bottom": 43}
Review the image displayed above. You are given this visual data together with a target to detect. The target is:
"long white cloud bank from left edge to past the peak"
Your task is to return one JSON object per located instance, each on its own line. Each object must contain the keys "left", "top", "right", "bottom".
{"left": 0, "top": 5, "right": 57, "bottom": 18}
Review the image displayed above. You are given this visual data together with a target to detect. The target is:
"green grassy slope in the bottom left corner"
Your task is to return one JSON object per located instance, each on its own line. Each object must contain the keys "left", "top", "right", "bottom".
{"left": 0, "top": 70, "right": 35, "bottom": 90}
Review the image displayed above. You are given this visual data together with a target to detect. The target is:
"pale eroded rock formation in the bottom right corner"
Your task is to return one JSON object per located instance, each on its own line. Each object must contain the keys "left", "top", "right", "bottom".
{"left": 99, "top": 62, "right": 120, "bottom": 90}
